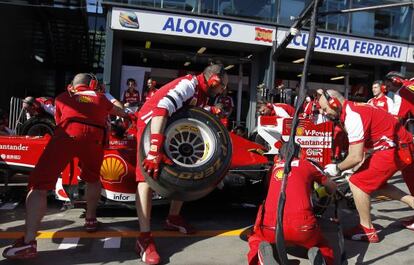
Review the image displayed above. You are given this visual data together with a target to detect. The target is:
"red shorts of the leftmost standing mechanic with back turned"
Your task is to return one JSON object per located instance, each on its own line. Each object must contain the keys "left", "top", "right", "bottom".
{"left": 28, "top": 123, "right": 104, "bottom": 190}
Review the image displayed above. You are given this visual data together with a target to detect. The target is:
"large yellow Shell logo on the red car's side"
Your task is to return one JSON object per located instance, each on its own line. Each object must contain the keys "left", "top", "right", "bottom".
{"left": 101, "top": 155, "right": 128, "bottom": 183}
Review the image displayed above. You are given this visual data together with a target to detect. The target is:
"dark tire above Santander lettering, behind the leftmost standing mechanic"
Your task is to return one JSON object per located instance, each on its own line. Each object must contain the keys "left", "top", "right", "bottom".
{"left": 20, "top": 116, "right": 56, "bottom": 136}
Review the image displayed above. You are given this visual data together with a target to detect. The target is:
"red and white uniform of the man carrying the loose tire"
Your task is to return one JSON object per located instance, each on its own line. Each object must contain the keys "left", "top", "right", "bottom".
{"left": 136, "top": 74, "right": 208, "bottom": 182}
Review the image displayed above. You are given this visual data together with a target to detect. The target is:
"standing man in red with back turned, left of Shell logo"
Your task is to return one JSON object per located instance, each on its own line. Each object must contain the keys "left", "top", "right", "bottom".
{"left": 3, "top": 73, "right": 128, "bottom": 259}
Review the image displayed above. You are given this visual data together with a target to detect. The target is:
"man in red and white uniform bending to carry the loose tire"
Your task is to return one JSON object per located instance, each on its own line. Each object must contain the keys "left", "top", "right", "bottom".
{"left": 136, "top": 64, "right": 228, "bottom": 264}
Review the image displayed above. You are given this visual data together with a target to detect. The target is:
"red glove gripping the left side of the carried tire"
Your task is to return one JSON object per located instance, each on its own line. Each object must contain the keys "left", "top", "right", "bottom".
{"left": 142, "top": 134, "right": 173, "bottom": 179}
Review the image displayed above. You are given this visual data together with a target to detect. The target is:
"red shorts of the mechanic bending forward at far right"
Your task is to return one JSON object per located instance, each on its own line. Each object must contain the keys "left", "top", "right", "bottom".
{"left": 349, "top": 148, "right": 402, "bottom": 194}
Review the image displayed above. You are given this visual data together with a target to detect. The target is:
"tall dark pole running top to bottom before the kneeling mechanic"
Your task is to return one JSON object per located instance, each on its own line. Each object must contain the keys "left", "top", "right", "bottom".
{"left": 275, "top": 0, "right": 319, "bottom": 265}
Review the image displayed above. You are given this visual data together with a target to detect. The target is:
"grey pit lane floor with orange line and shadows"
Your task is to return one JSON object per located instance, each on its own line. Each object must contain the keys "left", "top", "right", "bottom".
{"left": 0, "top": 174, "right": 414, "bottom": 265}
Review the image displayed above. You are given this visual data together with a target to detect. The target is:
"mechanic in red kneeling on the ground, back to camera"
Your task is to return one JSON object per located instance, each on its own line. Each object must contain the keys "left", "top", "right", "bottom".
{"left": 247, "top": 144, "right": 336, "bottom": 265}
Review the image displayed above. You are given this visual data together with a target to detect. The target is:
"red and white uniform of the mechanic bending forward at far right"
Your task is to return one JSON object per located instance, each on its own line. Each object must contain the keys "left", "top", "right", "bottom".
{"left": 340, "top": 100, "right": 414, "bottom": 194}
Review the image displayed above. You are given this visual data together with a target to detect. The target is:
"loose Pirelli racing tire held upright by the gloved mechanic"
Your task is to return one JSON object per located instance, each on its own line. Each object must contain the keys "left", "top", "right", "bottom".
{"left": 138, "top": 107, "right": 232, "bottom": 201}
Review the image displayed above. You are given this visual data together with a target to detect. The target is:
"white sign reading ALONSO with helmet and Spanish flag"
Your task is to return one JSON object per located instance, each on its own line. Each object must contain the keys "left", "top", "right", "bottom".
{"left": 111, "top": 8, "right": 275, "bottom": 46}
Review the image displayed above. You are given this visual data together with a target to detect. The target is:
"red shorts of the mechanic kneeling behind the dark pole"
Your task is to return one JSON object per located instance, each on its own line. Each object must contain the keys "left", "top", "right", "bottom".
{"left": 247, "top": 205, "right": 334, "bottom": 265}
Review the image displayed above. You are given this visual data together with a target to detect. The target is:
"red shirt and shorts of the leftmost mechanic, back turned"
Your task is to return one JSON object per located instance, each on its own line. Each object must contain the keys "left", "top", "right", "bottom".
{"left": 29, "top": 91, "right": 113, "bottom": 190}
